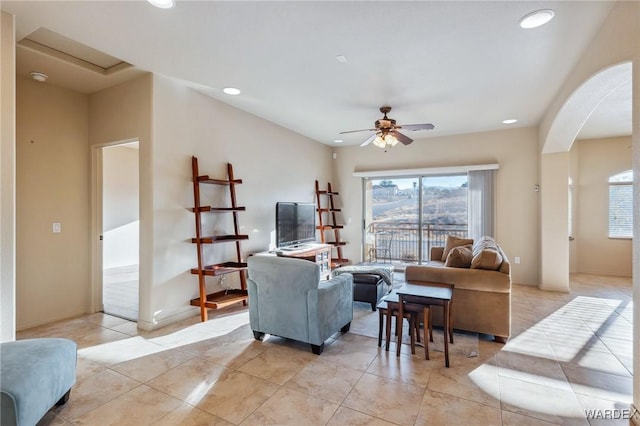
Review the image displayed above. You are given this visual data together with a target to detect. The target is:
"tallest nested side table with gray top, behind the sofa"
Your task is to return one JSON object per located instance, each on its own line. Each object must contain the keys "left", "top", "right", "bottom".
{"left": 396, "top": 283, "right": 453, "bottom": 367}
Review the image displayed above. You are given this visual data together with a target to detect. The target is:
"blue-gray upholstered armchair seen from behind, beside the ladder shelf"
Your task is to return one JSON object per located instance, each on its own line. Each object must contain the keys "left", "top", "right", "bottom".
{"left": 247, "top": 255, "right": 353, "bottom": 355}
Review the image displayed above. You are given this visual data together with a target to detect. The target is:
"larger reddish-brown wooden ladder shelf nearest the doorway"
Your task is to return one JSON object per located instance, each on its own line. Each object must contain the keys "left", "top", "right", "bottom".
{"left": 191, "top": 156, "right": 249, "bottom": 321}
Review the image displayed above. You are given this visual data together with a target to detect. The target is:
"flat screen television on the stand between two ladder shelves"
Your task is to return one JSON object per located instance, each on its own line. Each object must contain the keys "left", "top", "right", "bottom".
{"left": 276, "top": 202, "right": 316, "bottom": 248}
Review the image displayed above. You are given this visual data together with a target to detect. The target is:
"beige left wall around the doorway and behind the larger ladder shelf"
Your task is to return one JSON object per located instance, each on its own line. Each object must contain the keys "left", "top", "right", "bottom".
{"left": 12, "top": 70, "right": 332, "bottom": 329}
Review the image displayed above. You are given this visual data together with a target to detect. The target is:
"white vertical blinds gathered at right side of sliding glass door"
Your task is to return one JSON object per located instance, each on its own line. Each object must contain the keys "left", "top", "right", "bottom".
{"left": 468, "top": 170, "right": 495, "bottom": 240}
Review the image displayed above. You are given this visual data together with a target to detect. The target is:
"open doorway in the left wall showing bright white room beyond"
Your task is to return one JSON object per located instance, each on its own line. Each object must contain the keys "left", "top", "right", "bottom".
{"left": 100, "top": 141, "right": 140, "bottom": 321}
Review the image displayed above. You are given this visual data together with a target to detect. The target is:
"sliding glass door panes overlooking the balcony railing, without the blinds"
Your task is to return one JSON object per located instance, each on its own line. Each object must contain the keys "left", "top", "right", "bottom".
{"left": 363, "top": 173, "right": 468, "bottom": 263}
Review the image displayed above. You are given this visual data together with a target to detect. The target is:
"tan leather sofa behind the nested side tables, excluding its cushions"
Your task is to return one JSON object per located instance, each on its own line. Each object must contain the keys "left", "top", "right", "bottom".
{"left": 405, "top": 247, "right": 511, "bottom": 343}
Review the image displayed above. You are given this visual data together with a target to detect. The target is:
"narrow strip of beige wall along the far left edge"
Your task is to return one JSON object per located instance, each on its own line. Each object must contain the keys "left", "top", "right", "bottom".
{"left": 0, "top": 12, "right": 16, "bottom": 342}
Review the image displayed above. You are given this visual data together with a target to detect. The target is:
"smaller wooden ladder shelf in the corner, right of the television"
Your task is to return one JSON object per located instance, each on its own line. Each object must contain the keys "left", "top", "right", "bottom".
{"left": 316, "top": 180, "right": 350, "bottom": 269}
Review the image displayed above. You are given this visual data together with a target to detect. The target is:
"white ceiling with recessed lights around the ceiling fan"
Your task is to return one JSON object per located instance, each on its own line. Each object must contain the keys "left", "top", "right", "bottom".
{"left": 1, "top": 0, "right": 631, "bottom": 146}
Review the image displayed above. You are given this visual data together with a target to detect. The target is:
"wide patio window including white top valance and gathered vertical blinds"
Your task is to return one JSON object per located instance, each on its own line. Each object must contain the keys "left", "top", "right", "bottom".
{"left": 353, "top": 164, "right": 499, "bottom": 263}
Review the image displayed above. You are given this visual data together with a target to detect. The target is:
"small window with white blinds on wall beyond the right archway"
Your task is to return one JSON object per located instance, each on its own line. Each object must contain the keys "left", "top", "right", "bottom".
{"left": 609, "top": 170, "right": 633, "bottom": 238}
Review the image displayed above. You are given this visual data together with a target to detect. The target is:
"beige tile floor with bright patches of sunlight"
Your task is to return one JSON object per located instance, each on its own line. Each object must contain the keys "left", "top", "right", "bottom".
{"left": 18, "top": 275, "right": 633, "bottom": 426}
